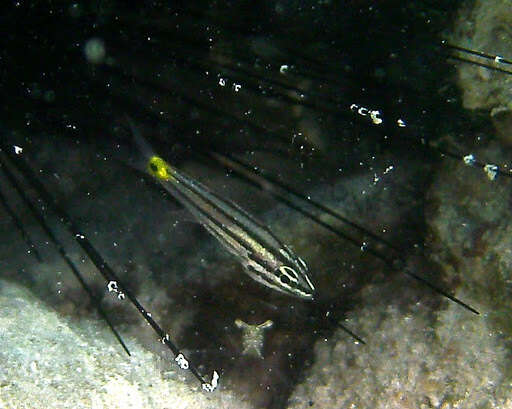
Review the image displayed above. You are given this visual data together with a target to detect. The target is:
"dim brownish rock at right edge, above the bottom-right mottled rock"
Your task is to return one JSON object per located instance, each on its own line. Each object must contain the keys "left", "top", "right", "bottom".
{"left": 427, "top": 143, "right": 512, "bottom": 358}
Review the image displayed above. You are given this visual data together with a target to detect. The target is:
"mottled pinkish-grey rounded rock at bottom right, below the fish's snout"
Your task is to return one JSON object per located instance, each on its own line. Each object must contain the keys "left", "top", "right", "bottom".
{"left": 289, "top": 272, "right": 512, "bottom": 409}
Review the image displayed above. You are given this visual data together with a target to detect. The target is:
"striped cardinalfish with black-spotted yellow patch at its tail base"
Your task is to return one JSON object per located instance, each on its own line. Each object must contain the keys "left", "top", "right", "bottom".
{"left": 130, "top": 123, "right": 315, "bottom": 300}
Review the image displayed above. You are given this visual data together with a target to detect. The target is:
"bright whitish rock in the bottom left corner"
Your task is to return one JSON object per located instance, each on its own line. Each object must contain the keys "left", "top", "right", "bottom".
{"left": 0, "top": 281, "right": 250, "bottom": 409}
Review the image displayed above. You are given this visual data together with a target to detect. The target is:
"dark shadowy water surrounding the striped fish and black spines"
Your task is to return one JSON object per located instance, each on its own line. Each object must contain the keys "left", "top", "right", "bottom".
{"left": 0, "top": 0, "right": 508, "bottom": 408}
